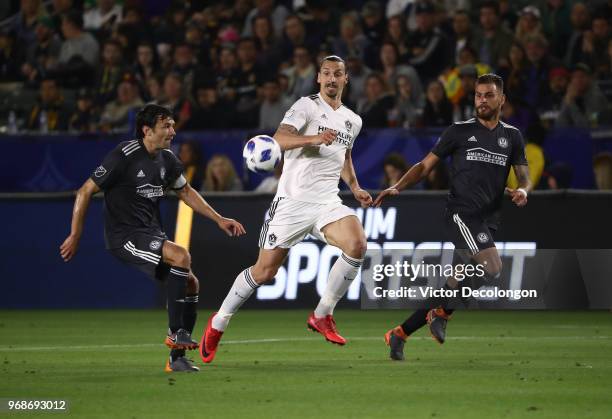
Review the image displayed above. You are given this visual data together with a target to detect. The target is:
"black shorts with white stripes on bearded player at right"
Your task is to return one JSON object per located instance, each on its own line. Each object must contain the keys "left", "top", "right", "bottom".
{"left": 446, "top": 213, "right": 496, "bottom": 255}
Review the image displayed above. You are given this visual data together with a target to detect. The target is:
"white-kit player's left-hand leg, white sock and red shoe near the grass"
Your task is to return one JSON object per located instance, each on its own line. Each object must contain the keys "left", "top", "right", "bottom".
{"left": 200, "top": 247, "right": 289, "bottom": 363}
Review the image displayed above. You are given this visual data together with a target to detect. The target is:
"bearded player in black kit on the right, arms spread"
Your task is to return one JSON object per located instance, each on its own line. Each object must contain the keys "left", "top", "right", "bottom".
{"left": 373, "top": 74, "right": 531, "bottom": 360}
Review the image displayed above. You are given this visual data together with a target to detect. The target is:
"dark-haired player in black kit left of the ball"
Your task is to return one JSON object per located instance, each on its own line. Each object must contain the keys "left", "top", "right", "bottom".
{"left": 60, "top": 105, "right": 245, "bottom": 372}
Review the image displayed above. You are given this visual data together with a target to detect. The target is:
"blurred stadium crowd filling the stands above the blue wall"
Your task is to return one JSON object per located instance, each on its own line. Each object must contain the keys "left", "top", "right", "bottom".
{"left": 0, "top": 0, "right": 612, "bottom": 188}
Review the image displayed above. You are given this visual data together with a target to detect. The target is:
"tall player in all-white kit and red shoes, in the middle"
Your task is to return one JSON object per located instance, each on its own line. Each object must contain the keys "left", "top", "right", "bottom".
{"left": 200, "top": 55, "right": 372, "bottom": 363}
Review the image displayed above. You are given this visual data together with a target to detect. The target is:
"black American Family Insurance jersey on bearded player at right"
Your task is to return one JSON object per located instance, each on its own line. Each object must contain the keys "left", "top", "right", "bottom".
{"left": 432, "top": 118, "right": 527, "bottom": 225}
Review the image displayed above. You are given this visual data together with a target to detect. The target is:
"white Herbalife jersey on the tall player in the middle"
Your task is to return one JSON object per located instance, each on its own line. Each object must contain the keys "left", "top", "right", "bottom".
{"left": 276, "top": 94, "right": 362, "bottom": 204}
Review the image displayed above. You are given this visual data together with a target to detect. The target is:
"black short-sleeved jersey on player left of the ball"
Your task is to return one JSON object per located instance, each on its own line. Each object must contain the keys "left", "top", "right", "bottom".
{"left": 91, "top": 140, "right": 187, "bottom": 249}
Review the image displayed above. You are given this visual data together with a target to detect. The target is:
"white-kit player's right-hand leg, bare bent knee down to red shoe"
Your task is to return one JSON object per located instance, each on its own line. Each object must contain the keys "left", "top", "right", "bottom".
{"left": 306, "top": 216, "right": 367, "bottom": 345}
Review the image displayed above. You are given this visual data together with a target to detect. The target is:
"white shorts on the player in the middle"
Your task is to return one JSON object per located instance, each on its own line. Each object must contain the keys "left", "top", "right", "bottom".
{"left": 259, "top": 197, "right": 355, "bottom": 249}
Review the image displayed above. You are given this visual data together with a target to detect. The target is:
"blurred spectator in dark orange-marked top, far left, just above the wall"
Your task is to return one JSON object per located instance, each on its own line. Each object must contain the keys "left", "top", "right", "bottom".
{"left": 27, "top": 78, "right": 70, "bottom": 133}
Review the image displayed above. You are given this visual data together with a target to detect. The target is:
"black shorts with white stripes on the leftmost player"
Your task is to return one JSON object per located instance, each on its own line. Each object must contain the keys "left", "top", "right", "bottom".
{"left": 109, "top": 232, "right": 170, "bottom": 280}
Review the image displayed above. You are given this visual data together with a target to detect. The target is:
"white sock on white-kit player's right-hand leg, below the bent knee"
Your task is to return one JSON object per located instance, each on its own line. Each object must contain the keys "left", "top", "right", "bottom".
{"left": 315, "top": 253, "right": 363, "bottom": 318}
